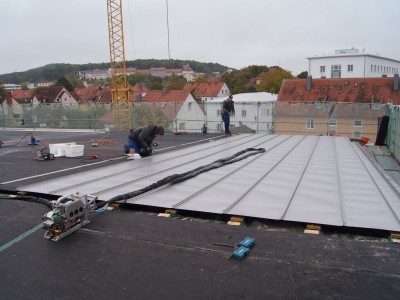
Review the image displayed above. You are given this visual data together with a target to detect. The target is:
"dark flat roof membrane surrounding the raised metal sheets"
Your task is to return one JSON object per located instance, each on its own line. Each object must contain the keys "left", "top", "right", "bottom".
{"left": 0, "top": 130, "right": 400, "bottom": 299}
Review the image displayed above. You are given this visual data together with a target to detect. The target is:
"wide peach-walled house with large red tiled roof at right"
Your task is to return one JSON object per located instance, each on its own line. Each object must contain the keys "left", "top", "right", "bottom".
{"left": 274, "top": 75, "right": 400, "bottom": 142}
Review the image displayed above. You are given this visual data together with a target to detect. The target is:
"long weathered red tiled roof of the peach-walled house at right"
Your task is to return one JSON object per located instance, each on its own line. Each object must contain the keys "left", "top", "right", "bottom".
{"left": 278, "top": 77, "right": 400, "bottom": 105}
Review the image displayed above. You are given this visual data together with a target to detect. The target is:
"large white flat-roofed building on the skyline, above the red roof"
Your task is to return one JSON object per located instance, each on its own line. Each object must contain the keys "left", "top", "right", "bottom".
{"left": 307, "top": 48, "right": 400, "bottom": 78}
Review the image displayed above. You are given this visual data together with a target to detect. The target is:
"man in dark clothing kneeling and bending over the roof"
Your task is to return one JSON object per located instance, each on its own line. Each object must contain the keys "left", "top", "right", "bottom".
{"left": 124, "top": 125, "right": 164, "bottom": 157}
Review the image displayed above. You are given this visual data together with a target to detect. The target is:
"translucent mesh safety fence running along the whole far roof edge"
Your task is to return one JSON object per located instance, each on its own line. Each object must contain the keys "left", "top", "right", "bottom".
{"left": 0, "top": 101, "right": 390, "bottom": 142}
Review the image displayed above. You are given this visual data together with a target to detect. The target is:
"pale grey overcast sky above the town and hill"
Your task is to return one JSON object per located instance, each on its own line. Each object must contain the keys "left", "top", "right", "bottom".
{"left": 0, "top": 0, "right": 400, "bottom": 75}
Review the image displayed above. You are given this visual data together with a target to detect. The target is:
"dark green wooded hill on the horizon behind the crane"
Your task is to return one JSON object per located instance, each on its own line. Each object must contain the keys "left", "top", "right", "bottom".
{"left": 0, "top": 59, "right": 230, "bottom": 84}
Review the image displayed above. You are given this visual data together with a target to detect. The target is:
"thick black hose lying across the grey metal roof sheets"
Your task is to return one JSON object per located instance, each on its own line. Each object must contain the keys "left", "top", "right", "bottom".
{"left": 101, "top": 148, "right": 265, "bottom": 207}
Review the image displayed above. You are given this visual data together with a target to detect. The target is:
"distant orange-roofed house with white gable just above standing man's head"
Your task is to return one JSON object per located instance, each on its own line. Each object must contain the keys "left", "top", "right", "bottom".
{"left": 183, "top": 82, "right": 230, "bottom": 101}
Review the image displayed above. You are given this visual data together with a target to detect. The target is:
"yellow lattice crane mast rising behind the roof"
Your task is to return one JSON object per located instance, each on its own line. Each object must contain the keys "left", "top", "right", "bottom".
{"left": 107, "top": 0, "right": 132, "bottom": 130}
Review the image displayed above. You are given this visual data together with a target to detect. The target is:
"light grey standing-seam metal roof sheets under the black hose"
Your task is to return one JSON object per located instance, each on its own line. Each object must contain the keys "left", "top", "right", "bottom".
{"left": 19, "top": 134, "right": 400, "bottom": 231}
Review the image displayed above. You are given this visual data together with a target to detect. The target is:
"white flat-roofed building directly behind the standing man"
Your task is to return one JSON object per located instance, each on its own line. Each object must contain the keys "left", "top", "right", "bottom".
{"left": 204, "top": 92, "right": 278, "bottom": 133}
